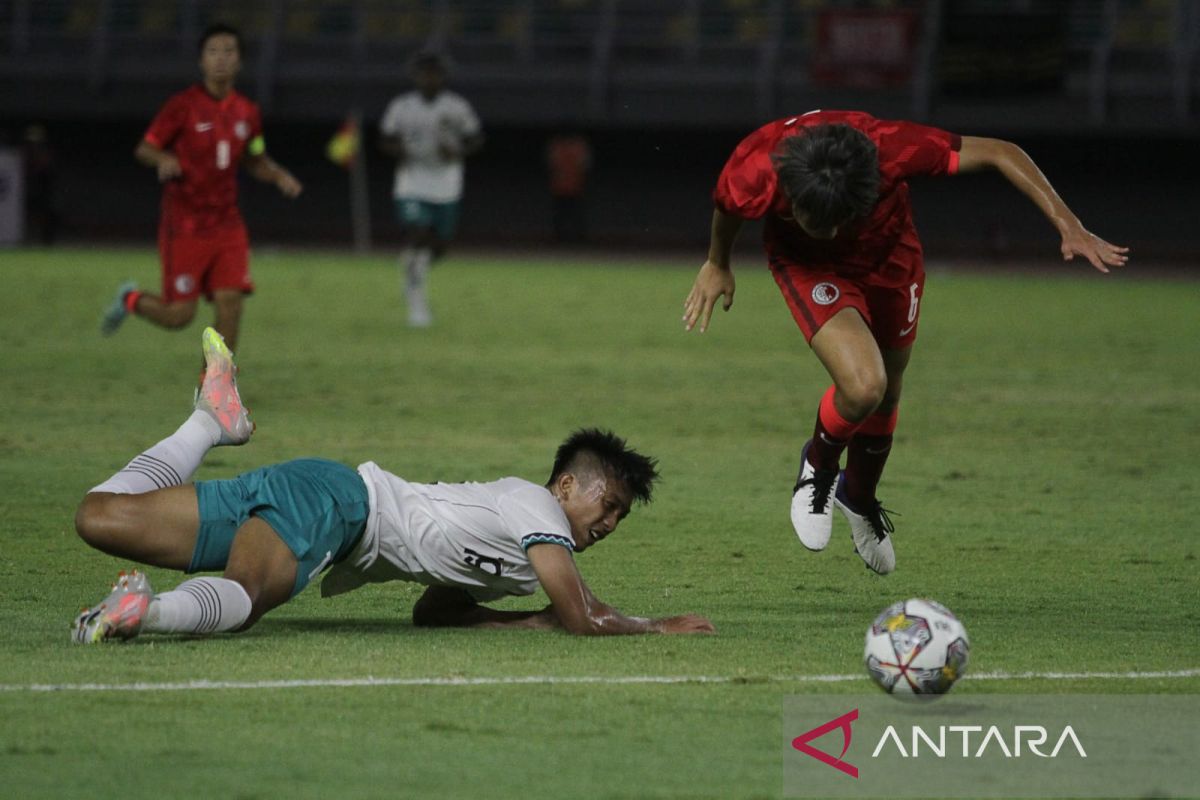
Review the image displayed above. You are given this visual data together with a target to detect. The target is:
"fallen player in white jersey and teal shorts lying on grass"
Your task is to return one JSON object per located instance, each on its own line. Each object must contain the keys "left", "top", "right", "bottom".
{"left": 72, "top": 327, "right": 714, "bottom": 644}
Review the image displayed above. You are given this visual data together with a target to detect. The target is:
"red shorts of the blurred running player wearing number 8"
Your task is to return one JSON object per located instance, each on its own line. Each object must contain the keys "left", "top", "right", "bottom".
{"left": 158, "top": 223, "right": 254, "bottom": 302}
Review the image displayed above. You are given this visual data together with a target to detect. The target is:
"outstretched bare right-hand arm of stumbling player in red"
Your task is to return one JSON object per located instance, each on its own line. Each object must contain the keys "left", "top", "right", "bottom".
{"left": 959, "top": 137, "right": 1129, "bottom": 272}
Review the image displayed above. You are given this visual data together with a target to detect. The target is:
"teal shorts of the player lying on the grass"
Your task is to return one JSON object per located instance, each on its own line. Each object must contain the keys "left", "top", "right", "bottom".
{"left": 187, "top": 458, "right": 370, "bottom": 597}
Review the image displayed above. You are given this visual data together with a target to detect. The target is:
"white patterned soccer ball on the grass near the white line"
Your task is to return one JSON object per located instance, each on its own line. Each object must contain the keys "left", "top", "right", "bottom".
{"left": 863, "top": 600, "right": 971, "bottom": 694}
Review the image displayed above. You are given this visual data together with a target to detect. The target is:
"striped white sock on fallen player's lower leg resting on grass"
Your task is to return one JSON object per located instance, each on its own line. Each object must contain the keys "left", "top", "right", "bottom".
{"left": 142, "top": 578, "right": 251, "bottom": 633}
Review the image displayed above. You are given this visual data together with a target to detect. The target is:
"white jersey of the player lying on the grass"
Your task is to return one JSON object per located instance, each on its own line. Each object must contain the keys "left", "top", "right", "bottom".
{"left": 320, "top": 462, "right": 574, "bottom": 601}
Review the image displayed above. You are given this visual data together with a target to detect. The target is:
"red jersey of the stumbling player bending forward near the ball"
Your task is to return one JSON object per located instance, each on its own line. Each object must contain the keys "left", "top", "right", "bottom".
{"left": 713, "top": 112, "right": 961, "bottom": 287}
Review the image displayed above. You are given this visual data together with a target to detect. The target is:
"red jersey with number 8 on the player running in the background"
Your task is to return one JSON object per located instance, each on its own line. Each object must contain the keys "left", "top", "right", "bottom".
{"left": 143, "top": 84, "right": 263, "bottom": 234}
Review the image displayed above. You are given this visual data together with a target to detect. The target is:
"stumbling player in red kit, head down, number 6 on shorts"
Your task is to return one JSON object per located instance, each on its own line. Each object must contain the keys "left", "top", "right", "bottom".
{"left": 683, "top": 112, "right": 1128, "bottom": 573}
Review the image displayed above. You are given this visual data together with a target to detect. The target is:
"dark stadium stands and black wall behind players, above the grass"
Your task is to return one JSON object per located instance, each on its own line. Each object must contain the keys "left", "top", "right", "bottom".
{"left": 0, "top": 0, "right": 1200, "bottom": 266}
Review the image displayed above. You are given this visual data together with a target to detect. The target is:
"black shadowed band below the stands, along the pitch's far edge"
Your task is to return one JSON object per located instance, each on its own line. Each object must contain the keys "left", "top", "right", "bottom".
{"left": 7, "top": 120, "right": 1200, "bottom": 259}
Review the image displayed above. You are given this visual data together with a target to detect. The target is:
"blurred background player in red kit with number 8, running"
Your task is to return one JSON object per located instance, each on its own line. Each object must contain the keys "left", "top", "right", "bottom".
{"left": 101, "top": 24, "right": 302, "bottom": 357}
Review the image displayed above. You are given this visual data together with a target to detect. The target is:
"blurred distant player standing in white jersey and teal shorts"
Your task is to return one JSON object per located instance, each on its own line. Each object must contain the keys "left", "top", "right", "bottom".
{"left": 379, "top": 52, "right": 484, "bottom": 327}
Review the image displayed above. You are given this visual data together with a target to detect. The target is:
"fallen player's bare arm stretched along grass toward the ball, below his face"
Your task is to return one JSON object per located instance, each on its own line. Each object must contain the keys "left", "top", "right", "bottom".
{"left": 528, "top": 543, "right": 716, "bottom": 636}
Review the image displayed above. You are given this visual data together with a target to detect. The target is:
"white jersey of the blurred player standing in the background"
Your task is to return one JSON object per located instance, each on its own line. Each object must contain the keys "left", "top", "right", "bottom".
{"left": 379, "top": 91, "right": 480, "bottom": 203}
